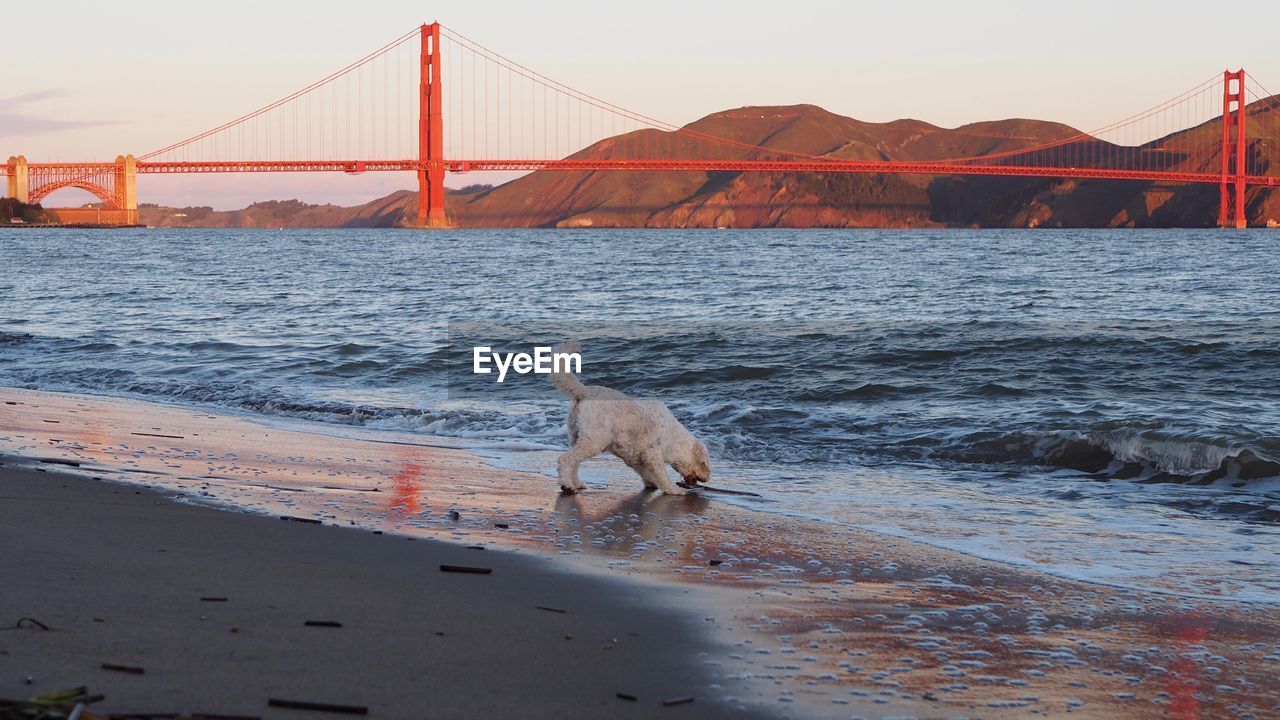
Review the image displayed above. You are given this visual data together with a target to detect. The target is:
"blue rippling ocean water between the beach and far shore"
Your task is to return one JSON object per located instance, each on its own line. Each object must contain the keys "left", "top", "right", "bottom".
{"left": 0, "top": 229, "right": 1280, "bottom": 602}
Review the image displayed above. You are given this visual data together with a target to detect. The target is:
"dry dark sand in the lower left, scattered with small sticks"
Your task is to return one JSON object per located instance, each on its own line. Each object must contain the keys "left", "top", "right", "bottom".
{"left": 0, "top": 468, "right": 757, "bottom": 719}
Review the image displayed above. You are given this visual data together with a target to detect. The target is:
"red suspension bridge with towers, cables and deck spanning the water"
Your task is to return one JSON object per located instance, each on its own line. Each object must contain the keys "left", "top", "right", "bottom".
{"left": 0, "top": 23, "right": 1280, "bottom": 228}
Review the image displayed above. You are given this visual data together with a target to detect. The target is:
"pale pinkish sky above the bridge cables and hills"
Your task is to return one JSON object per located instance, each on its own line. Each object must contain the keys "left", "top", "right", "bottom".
{"left": 0, "top": 0, "right": 1280, "bottom": 209}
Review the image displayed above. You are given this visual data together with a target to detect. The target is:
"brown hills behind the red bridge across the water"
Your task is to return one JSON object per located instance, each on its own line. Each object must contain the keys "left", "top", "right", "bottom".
{"left": 142, "top": 100, "right": 1280, "bottom": 228}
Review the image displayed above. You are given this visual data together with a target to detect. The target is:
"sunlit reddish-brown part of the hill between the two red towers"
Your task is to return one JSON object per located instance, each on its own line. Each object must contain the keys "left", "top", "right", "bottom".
{"left": 451, "top": 105, "right": 1078, "bottom": 228}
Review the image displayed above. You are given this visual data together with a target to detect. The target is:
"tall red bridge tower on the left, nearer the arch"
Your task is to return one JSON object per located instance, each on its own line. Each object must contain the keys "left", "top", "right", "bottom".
{"left": 417, "top": 23, "right": 449, "bottom": 228}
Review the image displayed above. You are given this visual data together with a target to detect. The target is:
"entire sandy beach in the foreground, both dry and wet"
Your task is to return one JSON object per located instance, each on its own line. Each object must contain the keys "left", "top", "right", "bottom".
{"left": 0, "top": 389, "right": 1280, "bottom": 717}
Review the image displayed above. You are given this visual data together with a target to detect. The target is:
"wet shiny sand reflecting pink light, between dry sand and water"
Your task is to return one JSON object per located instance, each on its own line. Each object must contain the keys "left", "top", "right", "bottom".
{"left": 0, "top": 389, "right": 1280, "bottom": 717}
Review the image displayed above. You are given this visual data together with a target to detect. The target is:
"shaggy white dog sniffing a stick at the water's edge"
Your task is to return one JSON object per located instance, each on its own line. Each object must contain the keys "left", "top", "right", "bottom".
{"left": 552, "top": 341, "right": 712, "bottom": 495}
